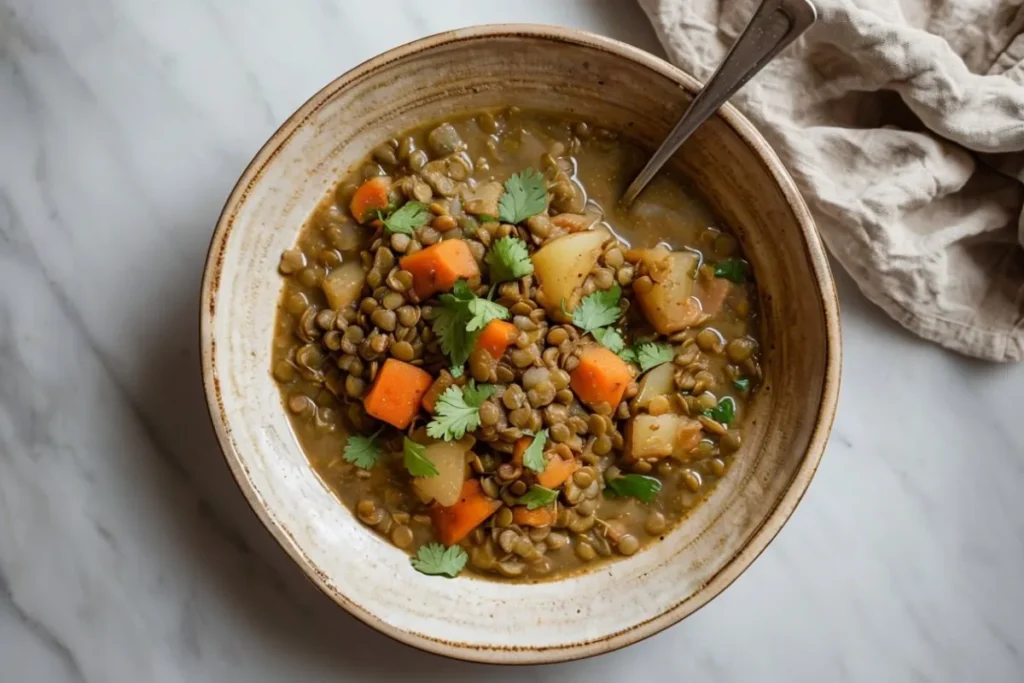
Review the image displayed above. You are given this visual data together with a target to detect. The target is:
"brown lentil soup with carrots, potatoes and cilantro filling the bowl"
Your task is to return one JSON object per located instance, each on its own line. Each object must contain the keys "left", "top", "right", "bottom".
{"left": 272, "top": 108, "right": 761, "bottom": 581}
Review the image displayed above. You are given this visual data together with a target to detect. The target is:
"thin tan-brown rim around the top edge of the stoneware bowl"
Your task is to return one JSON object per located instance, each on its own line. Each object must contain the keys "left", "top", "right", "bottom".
{"left": 200, "top": 24, "right": 841, "bottom": 665}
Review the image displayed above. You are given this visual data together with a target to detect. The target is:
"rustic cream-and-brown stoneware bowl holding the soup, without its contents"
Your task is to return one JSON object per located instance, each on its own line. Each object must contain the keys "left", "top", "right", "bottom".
{"left": 202, "top": 26, "right": 840, "bottom": 664}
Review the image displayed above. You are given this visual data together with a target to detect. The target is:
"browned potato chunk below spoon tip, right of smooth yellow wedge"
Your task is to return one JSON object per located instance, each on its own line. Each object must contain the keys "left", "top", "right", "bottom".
{"left": 633, "top": 251, "right": 700, "bottom": 335}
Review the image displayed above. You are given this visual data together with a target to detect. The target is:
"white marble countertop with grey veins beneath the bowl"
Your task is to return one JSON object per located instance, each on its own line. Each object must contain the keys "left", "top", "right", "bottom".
{"left": 0, "top": 0, "right": 1024, "bottom": 683}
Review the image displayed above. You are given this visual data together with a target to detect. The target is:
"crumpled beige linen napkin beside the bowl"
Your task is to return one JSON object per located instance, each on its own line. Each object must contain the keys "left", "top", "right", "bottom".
{"left": 639, "top": 0, "right": 1024, "bottom": 360}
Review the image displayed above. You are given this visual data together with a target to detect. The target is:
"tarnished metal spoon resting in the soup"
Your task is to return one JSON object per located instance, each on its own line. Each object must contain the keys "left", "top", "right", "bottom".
{"left": 623, "top": 0, "right": 817, "bottom": 206}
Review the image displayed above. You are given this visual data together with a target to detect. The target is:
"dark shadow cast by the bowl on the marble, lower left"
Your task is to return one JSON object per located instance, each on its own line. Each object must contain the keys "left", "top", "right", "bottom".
{"left": 129, "top": 208, "right": 528, "bottom": 681}
